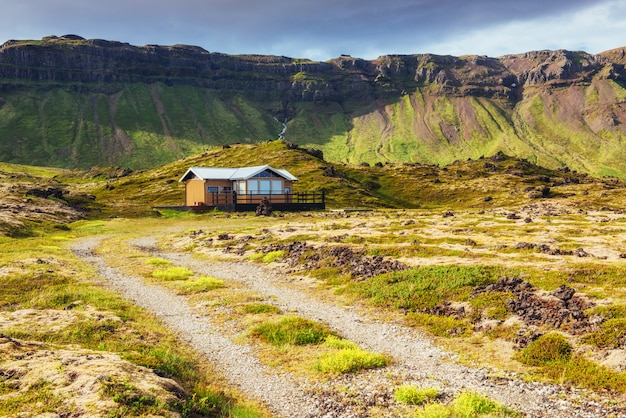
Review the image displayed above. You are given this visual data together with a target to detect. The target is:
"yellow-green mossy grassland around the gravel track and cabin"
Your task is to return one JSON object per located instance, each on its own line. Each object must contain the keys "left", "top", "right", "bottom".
{"left": 0, "top": 141, "right": 626, "bottom": 417}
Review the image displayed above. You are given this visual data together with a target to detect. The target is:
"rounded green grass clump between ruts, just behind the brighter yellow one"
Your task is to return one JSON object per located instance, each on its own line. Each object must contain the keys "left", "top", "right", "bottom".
{"left": 252, "top": 316, "right": 330, "bottom": 346}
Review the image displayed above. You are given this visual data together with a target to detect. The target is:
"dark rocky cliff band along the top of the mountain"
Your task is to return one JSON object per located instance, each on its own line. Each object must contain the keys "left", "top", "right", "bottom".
{"left": 0, "top": 35, "right": 626, "bottom": 100}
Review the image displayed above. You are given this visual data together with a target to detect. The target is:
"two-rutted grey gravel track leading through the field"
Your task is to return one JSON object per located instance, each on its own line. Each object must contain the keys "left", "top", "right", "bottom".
{"left": 73, "top": 238, "right": 609, "bottom": 417}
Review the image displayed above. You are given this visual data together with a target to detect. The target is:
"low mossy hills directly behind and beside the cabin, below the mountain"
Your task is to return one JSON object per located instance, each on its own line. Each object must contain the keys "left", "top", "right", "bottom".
{"left": 0, "top": 141, "right": 626, "bottom": 236}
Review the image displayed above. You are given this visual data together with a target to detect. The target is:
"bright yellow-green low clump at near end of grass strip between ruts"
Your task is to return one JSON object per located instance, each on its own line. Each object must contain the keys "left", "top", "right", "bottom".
{"left": 314, "top": 348, "right": 389, "bottom": 374}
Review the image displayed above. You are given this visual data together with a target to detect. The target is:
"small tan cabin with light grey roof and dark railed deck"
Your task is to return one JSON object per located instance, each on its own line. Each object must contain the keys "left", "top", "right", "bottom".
{"left": 179, "top": 165, "right": 325, "bottom": 211}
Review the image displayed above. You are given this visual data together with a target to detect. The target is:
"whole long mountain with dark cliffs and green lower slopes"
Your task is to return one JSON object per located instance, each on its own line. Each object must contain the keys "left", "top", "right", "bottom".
{"left": 0, "top": 35, "right": 626, "bottom": 178}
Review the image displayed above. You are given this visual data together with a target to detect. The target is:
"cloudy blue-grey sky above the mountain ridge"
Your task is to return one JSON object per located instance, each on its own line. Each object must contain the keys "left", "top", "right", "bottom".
{"left": 0, "top": 0, "right": 626, "bottom": 60}
